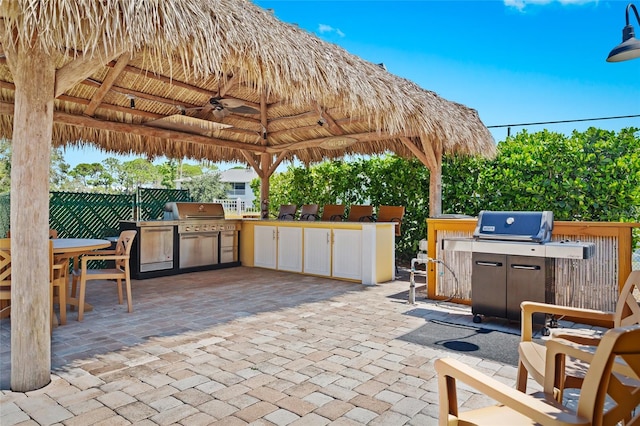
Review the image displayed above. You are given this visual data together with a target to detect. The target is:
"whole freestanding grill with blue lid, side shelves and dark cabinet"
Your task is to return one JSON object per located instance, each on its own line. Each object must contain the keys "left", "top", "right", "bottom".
{"left": 442, "top": 211, "right": 595, "bottom": 322}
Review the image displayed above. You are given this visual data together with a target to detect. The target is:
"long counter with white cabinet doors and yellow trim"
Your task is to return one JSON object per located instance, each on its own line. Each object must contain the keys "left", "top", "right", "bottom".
{"left": 240, "top": 219, "right": 395, "bottom": 285}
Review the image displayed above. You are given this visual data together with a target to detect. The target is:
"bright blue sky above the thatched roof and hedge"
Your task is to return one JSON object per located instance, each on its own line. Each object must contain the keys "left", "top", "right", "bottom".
{"left": 65, "top": 0, "right": 640, "bottom": 168}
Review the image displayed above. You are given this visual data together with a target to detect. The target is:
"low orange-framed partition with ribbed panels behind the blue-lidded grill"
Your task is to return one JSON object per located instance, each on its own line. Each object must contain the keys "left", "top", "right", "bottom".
{"left": 427, "top": 218, "right": 640, "bottom": 311}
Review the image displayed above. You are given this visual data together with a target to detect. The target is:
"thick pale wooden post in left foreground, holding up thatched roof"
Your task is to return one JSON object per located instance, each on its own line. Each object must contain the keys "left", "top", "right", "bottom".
{"left": 3, "top": 38, "right": 56, "bottom": 392}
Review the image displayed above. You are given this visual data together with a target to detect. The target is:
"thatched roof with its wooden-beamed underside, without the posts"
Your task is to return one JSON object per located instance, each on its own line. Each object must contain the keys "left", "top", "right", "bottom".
{"left": 0, "top": 0, "right": 494, "bottom": 163}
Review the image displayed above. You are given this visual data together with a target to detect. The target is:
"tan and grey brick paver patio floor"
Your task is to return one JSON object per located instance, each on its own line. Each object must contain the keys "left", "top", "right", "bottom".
{"left": 0, "top": 267, "right": 535, "bottom": 426}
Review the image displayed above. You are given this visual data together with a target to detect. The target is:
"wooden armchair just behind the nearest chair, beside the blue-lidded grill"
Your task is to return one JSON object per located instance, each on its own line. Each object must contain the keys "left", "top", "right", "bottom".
{"left": 516, "top": 271, "right": 640, "bottom": 401}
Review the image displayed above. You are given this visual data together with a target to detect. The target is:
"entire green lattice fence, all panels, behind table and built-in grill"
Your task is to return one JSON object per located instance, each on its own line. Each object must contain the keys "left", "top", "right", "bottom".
{"left": 0, "top": 188, "right": 191, "bottom": 238}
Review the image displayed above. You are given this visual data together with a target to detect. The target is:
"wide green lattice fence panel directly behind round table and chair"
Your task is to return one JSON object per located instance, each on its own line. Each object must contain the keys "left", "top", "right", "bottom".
{"left": 49, "top": 192, "right": 135, "bottom": 238}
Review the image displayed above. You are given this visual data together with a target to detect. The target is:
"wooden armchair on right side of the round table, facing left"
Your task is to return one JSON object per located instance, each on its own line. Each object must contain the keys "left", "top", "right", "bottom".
{"left": 72, "top": 230, "right": 137, "bottom": 321}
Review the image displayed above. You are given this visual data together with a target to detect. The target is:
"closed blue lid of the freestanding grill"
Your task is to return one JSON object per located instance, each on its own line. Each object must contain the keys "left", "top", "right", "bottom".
{"left": 473, "top": 210, "right": 553, "bottom": 243}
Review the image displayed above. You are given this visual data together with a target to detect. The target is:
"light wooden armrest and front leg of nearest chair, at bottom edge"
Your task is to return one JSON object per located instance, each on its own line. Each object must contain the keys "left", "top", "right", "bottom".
{"left": 435, "top": 358, "right": 589, "bottom": 425}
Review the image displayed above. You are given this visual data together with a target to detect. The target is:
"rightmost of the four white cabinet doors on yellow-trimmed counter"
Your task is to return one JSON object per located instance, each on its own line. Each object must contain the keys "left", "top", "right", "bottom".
{"left": 332, "top": 229, "right": 362, "bottom": 281}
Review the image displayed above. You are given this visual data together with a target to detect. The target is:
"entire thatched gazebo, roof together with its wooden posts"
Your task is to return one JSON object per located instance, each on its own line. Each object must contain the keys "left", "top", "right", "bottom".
{"left": 0, "top": 0, "right": 495, "bottom": 391}
